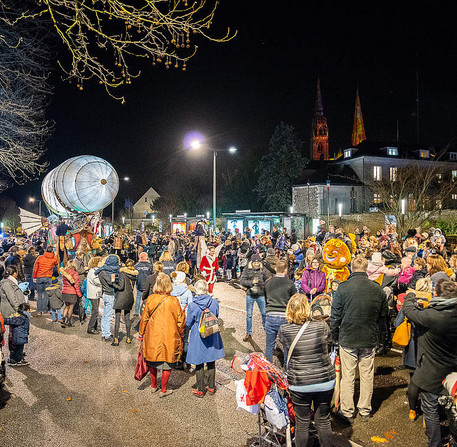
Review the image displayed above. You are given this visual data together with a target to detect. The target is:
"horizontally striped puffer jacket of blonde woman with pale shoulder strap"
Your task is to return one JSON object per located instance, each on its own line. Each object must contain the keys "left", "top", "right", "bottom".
{"left": 278, "top": 321, "right": 335, "bottom": 386}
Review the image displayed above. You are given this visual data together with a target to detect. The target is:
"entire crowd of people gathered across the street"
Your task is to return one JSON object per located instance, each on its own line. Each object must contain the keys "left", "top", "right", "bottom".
{"left": 0, "top": 222, "right": 457, "bottom": 446}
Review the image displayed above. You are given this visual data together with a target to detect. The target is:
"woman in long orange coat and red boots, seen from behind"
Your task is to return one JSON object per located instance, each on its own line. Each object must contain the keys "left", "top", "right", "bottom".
{"left": 138, "top": 273, "right": 186, "bottom": 397}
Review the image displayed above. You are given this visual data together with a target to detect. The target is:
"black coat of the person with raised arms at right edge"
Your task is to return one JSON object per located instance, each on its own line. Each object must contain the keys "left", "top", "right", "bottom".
{"left": 403, "top": 294, "right": 457, "bottom": 394}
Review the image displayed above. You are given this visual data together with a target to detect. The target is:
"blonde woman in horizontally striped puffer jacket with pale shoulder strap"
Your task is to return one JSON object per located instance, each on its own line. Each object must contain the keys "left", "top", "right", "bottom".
{"left": 278, "top": 293, "right": 335, "bottom": 447}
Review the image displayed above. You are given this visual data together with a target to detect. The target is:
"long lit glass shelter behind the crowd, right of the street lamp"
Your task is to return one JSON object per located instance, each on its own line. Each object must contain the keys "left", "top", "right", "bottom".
{"left": 222, "top": 211, "right": 312, "bottom": 239}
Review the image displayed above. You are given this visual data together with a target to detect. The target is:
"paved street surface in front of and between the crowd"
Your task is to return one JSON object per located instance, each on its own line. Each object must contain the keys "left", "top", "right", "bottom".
{"left": 0, "top": 283, "right": 426, "bottom": 447}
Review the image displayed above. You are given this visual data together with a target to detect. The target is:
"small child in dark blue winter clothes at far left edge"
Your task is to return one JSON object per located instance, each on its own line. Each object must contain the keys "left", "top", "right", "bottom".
{"left": 5, "top": 303, "right": 30, "bottom": 366}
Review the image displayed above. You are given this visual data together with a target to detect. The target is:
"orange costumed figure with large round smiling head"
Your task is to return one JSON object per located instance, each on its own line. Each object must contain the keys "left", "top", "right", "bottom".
{"left": 322, "top": 239, "right": 351, "bottom": 291}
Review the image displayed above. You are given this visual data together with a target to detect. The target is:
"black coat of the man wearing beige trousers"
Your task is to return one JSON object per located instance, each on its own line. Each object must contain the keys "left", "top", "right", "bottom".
{"left": 330, "top": 272, "right": 388, "bottom": 349}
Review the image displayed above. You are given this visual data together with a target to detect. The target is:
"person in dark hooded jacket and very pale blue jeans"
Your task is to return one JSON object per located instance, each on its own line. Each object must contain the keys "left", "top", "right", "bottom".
{"left": 95, "top": 255, "right": 120, "bottom": 341}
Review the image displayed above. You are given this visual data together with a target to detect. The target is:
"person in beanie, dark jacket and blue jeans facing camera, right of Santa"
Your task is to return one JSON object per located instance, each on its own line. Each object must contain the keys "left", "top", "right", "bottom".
{"left": 240, "top": 254, "right": 269, "bottom": 341}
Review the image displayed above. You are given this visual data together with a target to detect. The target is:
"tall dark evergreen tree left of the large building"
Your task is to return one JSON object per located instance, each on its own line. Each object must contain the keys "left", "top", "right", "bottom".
{"left": 255, "top": 123, "right": 307, "bottom": 211}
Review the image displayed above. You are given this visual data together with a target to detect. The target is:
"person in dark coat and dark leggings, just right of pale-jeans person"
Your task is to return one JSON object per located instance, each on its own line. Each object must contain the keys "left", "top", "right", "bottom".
{"left": 111, "top": 259, "right": 138, "bottom": 346}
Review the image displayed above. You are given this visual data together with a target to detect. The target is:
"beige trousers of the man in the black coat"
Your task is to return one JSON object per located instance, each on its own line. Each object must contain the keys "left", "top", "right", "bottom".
{"left": 340, "top": 346, "right": 375, "bottom": 417}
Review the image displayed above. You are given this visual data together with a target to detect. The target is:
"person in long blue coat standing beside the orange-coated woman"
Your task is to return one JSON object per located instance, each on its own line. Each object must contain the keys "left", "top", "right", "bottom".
{"left": 186, "top": 280, "right": 225, "bottom": 397}
